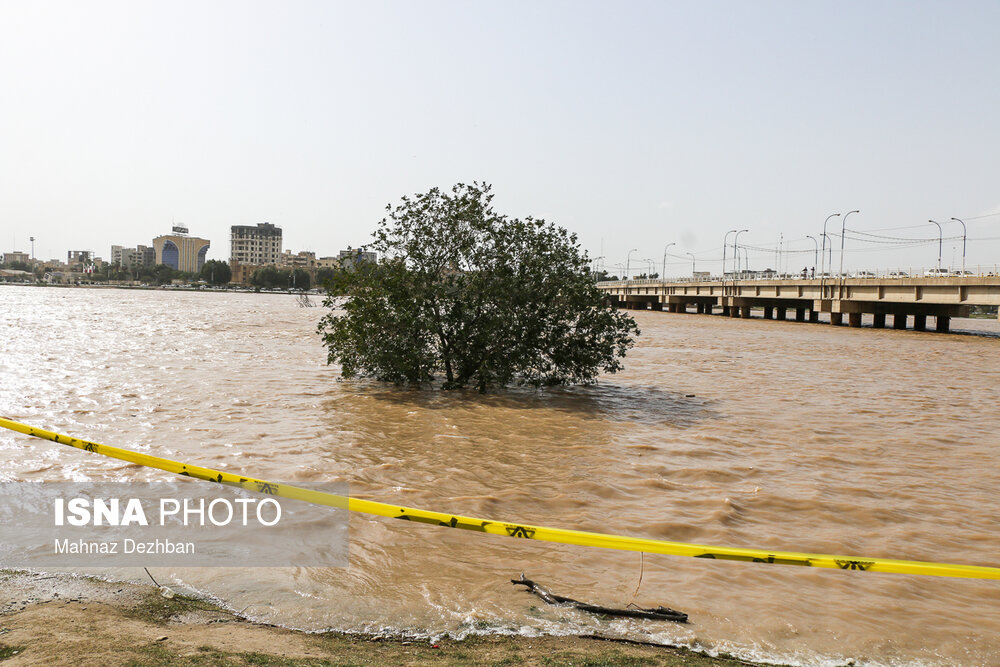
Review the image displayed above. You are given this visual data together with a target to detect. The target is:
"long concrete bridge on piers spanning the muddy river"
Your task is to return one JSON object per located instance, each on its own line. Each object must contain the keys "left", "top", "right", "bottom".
{"left": 597, "top": 276, "right": 1000, "bottom": 332}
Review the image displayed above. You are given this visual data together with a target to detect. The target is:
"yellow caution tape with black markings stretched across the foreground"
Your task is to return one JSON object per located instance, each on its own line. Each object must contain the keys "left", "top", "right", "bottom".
{"left": 0, "top": 417, "right": 1000, "bottom": 579}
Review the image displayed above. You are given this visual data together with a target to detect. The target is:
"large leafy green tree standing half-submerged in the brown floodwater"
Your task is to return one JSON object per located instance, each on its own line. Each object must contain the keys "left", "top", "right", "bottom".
{"left": 319, "top": 183, "right": 639, "bottom": 391}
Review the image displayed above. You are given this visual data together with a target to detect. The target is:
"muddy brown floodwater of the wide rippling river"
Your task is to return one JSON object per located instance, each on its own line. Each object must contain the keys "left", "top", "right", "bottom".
{"left": 0, "top": 287, "right": 1000, "bottom": 665}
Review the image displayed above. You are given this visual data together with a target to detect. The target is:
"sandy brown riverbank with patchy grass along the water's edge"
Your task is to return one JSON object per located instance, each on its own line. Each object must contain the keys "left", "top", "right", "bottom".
{"left": 0, "top": 571, "right": 751, "bottom": 667}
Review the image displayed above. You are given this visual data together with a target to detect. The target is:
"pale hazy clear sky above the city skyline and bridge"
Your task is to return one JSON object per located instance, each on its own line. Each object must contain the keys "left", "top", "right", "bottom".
{"left": 0, "top": 0, "right": 1000, "bottom": 275}
